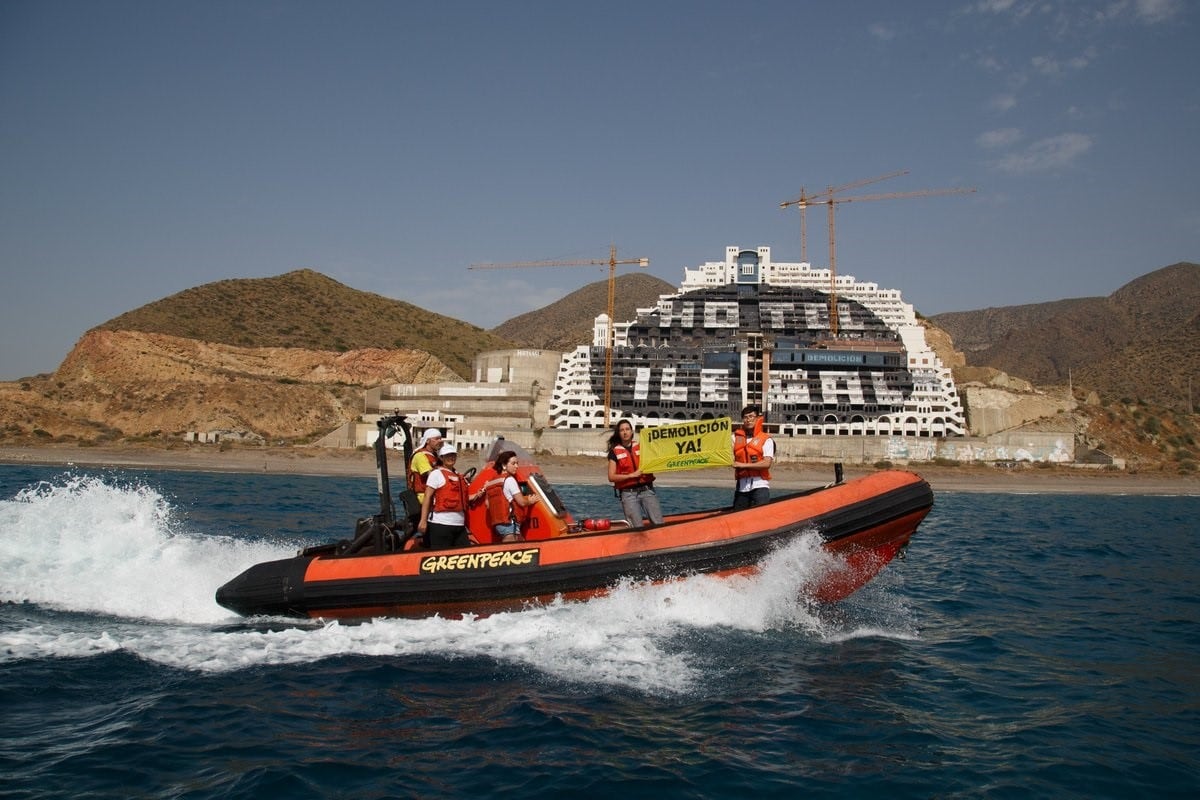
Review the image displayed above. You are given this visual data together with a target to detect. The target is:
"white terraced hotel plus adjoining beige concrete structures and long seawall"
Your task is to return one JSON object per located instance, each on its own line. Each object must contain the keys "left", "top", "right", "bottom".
{"left": 318, "top": 247, "right": 1074, "bottom": 463}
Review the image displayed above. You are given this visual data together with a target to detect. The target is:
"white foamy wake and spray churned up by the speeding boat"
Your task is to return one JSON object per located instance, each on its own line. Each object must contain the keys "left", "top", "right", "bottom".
{"left": 0, "top": 477, "right": 908, "bottom": 692}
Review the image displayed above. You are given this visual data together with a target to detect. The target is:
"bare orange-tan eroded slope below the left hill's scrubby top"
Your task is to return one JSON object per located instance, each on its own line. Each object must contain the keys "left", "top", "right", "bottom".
{"left": 0, "top": 329, "right": 458, "bottom": 441}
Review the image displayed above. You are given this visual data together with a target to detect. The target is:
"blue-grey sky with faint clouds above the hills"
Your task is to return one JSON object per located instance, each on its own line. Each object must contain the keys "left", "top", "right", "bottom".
{"left": 0, "top": 0, "right": 1200, "bottom": 380}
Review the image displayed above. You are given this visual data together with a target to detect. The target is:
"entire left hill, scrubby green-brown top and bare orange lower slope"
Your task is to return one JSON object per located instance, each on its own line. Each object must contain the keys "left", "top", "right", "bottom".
{"left": 0, "top": 270, "right": 512, "bottom": 441}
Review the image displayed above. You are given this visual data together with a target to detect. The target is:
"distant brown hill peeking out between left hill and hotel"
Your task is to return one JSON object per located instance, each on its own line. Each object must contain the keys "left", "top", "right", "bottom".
{"left": 492, "top": 272, "right": 677, "bottom": 351}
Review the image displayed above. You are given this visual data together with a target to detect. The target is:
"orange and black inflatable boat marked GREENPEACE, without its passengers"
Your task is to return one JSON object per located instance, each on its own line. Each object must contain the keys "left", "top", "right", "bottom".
{"left": 216, "top": 416, "right": 934, "bottom": 618}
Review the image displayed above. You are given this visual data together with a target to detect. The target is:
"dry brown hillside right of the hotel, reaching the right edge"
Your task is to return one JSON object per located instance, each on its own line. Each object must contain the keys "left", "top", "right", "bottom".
{"left": 931, "top": 263, "right": 1200, "bottom": 473}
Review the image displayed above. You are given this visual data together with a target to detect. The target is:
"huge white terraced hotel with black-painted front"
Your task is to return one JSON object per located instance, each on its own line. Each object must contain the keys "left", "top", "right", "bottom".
{"left": 550, "top": 246, "right": 966, "bottom": 437}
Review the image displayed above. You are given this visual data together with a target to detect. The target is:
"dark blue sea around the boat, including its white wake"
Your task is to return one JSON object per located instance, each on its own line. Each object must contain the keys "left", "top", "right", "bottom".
{"left": 0, "top": 467, "right": 1200, "bottom": 800}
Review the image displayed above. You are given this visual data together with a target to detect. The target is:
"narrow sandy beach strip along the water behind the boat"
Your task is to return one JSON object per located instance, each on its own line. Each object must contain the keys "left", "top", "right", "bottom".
{"left": 0, "top": 445, "right": 1200, "bottom": 497}
